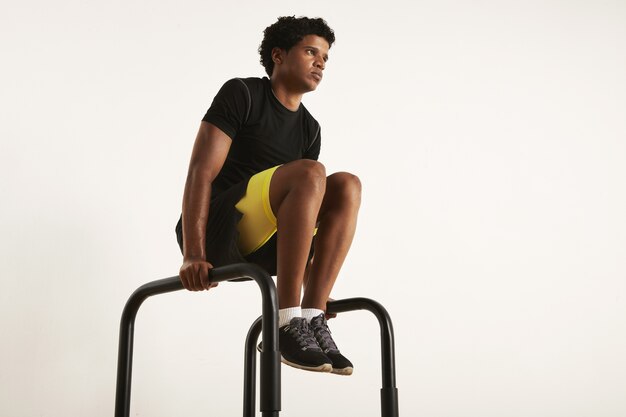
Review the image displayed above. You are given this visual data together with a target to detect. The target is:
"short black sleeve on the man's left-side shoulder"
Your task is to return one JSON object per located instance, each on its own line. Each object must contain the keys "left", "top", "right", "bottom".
{"left": 202, "top": 78, "right": 251, "bottom": 139}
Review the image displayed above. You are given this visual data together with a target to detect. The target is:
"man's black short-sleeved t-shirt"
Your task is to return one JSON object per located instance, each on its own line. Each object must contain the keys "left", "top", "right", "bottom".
{"left": 202, "top": 77, "right": 321, "bottom": 196}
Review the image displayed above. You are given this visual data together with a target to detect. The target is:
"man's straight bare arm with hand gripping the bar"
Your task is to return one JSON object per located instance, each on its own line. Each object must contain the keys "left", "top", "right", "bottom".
{"left": 180, "top": 122, "right": 231, "bottom": 291}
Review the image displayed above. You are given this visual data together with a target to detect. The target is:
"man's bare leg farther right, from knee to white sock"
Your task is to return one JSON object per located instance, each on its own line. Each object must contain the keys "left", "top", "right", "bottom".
{"left": 302, "top": 172, "right": 361, "bottom": 311}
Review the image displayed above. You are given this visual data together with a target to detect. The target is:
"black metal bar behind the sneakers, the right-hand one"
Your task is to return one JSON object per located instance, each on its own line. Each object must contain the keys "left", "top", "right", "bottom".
{"left": 244, "top": 298, "right": 399, "bottom": 417}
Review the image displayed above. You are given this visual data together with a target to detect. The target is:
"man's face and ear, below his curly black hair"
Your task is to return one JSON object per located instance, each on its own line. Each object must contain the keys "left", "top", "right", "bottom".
{"left": 272, "top": 35, "right": 330, "bottom": 93}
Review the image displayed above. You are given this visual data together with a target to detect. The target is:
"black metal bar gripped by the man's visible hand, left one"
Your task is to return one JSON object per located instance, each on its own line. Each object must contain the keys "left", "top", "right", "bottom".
{"left": 115, "top": 263, "right": 280, "bottom": 417}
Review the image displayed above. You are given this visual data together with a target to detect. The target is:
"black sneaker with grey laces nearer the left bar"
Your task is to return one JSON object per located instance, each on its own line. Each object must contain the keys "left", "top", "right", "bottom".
{"left": 257, "top": 317, "right": 333, "bottom": 372}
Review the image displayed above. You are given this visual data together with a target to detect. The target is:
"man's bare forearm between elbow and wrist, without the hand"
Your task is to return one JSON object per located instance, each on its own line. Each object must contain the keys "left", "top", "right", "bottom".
{"left": 183, "top": 167, "right": 211, "bottom": 260}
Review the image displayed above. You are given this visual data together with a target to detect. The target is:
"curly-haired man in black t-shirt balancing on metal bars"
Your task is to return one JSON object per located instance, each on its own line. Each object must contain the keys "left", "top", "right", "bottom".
{"left": 176, "top": 17, "right": 361, "bottom": 375}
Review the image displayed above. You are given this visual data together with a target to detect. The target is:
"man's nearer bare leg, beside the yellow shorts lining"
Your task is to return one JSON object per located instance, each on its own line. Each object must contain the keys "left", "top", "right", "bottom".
{"left": 270, "top": 160, "right": 326, "bottom": 308}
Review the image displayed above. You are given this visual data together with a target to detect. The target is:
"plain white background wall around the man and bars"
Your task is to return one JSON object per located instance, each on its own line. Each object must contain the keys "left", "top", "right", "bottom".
{"left": 0, "top": 0, "right": 626, "bottom": 417}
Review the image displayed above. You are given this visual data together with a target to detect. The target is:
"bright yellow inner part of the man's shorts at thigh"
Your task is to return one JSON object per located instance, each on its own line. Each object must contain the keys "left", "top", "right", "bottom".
{"left": 235, "top": 165, "right": 280, "bottom": 256}
